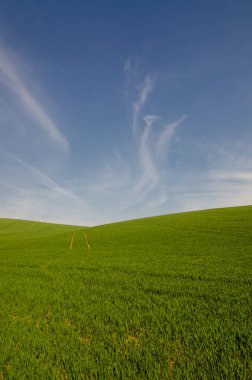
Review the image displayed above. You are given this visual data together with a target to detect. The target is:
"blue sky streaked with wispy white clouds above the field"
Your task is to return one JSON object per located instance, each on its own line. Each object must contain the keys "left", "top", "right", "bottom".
{"left": 0, "top": 0, "right": 252, "bottom": 226}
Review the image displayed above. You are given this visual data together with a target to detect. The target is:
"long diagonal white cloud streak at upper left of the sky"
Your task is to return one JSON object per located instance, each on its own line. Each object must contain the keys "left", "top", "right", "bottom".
{"left": 0, "top": 44, "right": 69, "bottom": 150}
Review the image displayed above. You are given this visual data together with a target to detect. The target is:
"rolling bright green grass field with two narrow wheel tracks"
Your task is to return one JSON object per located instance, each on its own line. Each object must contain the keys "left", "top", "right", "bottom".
{"left": 0, "top": 206, "right": 252, "bottom": 380}
